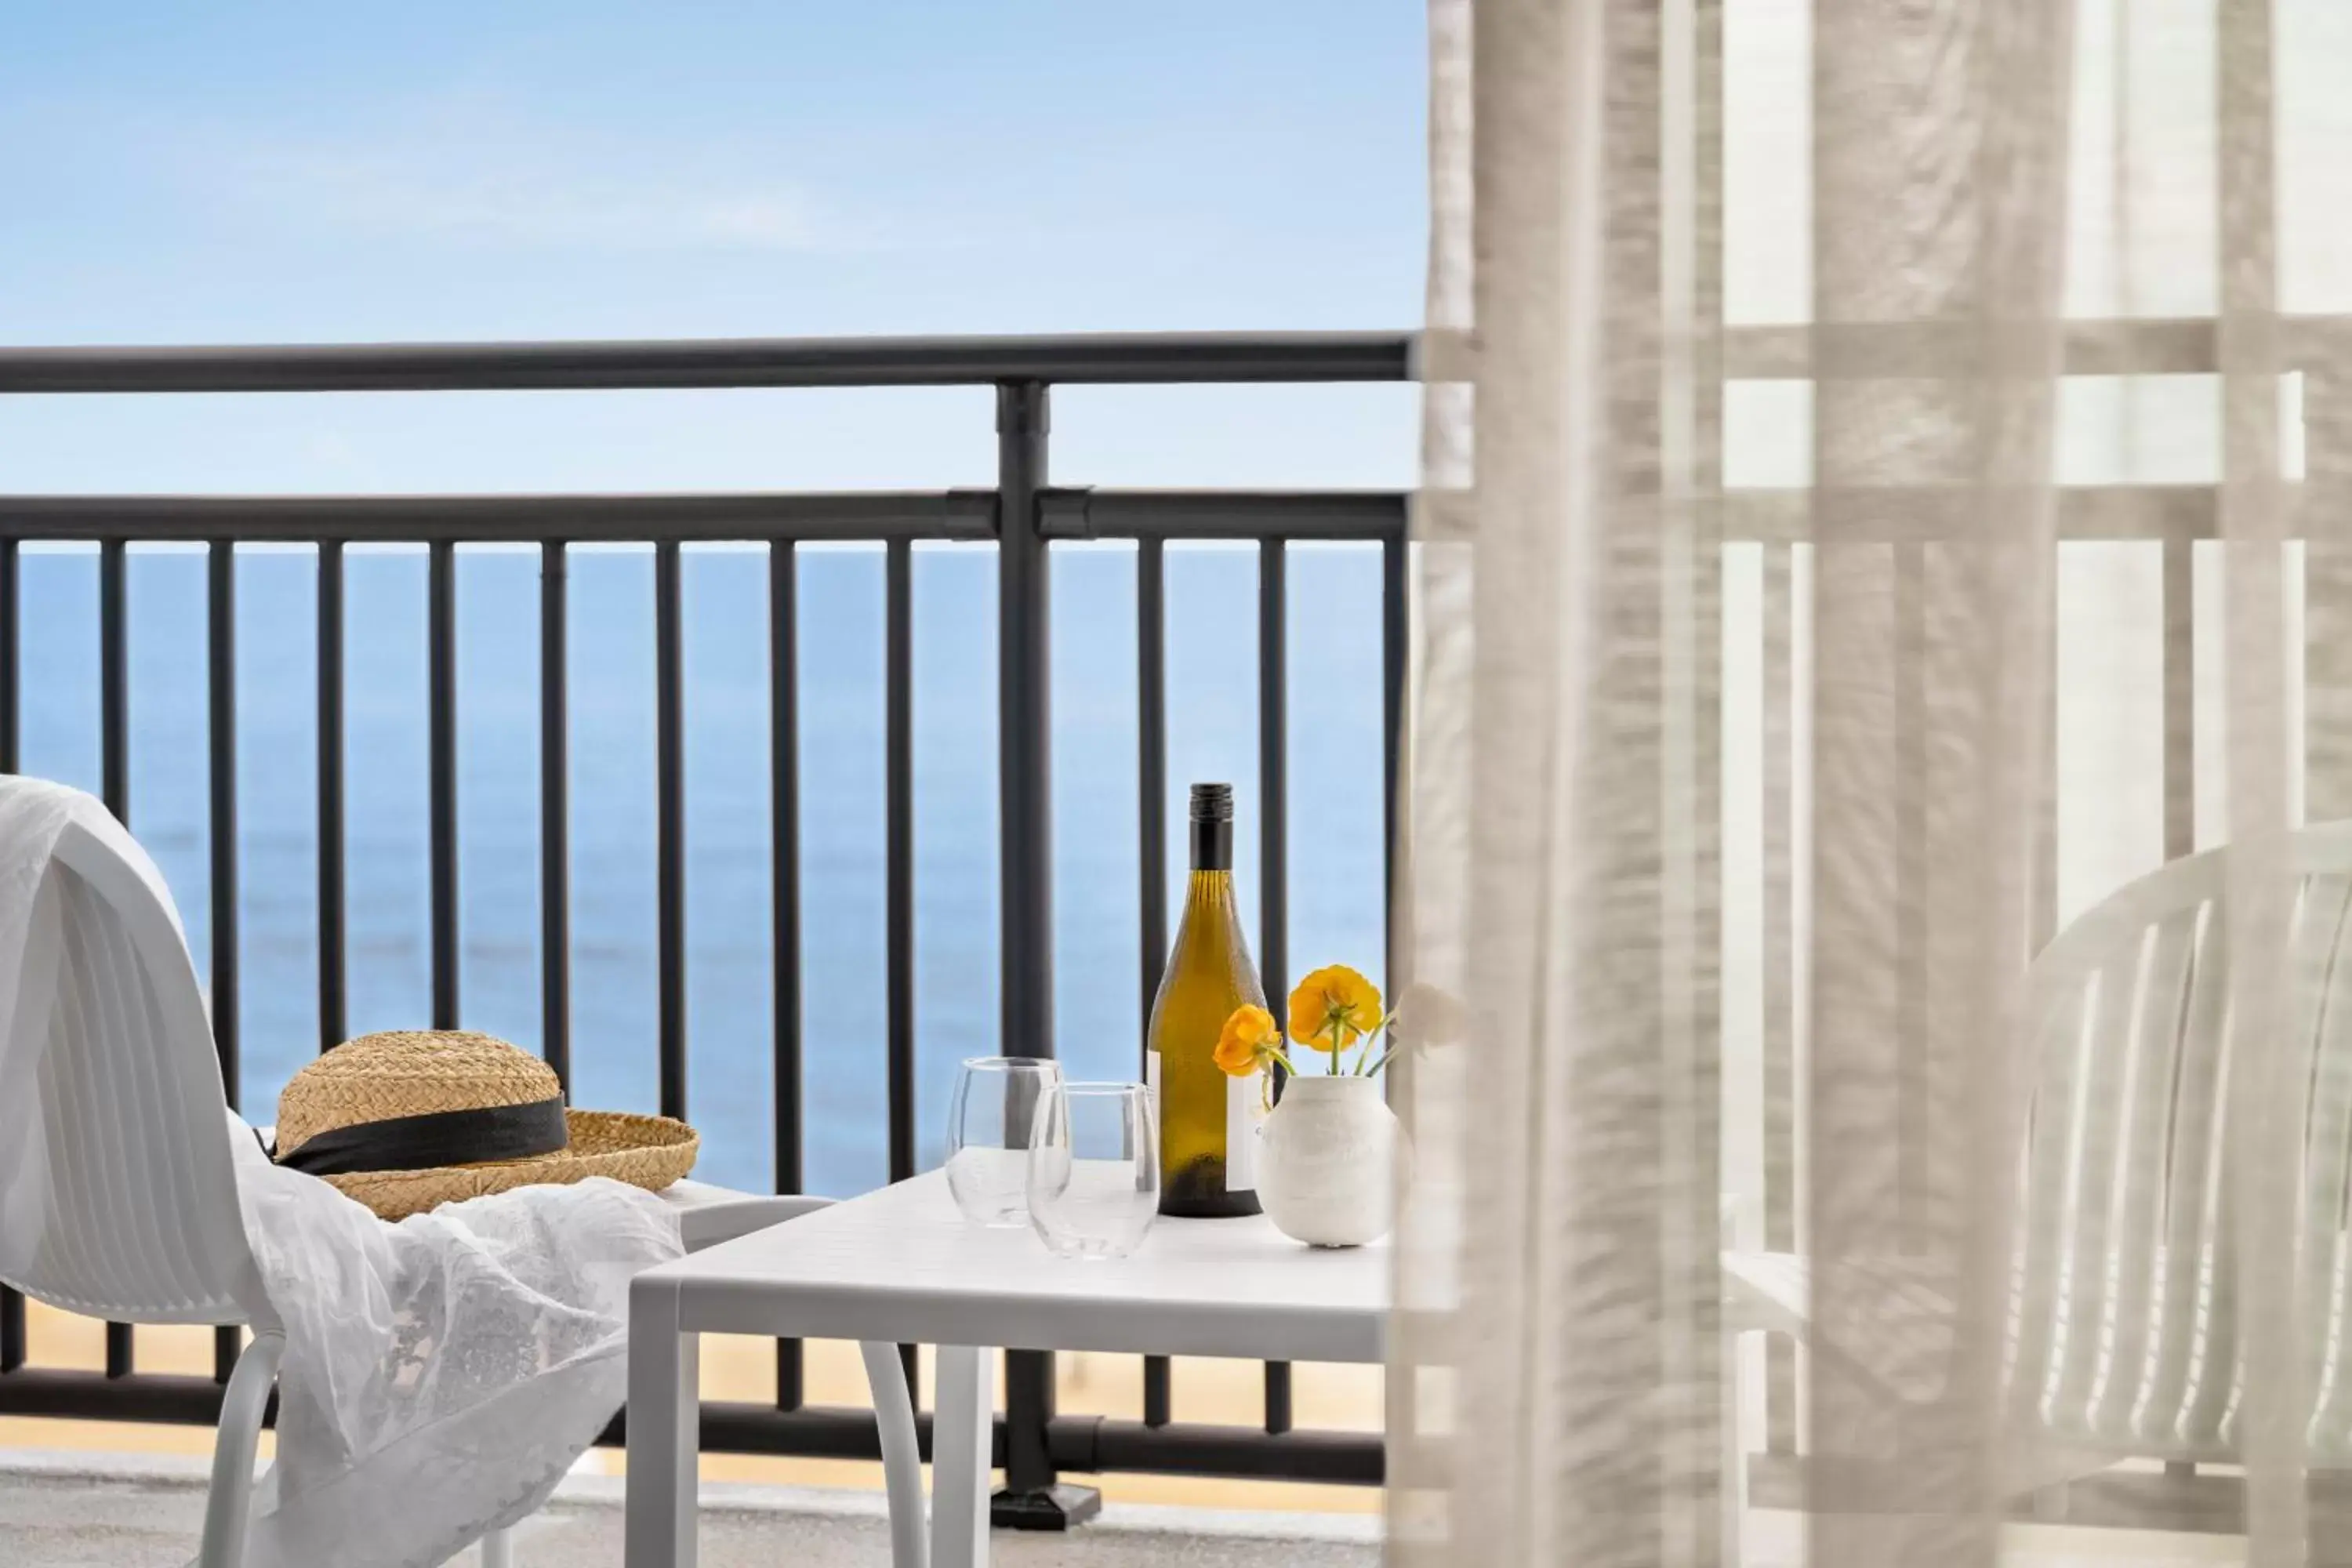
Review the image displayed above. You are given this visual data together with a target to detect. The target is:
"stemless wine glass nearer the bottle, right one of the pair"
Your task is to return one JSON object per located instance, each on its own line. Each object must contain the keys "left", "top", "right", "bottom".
{"left": 1028, "top": 1083, "right": 1160, "bottom": 1258}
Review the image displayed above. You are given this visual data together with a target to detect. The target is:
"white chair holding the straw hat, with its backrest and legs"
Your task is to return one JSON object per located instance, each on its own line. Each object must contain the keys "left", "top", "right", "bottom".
{"left": 0, "top": 799, "right": 922, "bottom": 1568}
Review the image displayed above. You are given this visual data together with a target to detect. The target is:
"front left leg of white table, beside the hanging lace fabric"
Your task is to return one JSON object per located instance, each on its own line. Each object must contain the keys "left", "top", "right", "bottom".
{"left": 626, "top": 1279, "right": 703, "bottom": 1568}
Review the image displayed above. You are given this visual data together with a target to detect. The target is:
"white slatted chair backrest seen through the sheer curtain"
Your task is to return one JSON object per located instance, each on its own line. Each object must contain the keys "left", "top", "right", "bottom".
{"left": 2013, "top": 822, "right": 2352, "bottom": 1462}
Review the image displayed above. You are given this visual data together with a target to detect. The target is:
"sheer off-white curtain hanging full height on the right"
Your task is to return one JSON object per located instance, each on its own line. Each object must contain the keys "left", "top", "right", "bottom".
{"left": 1390, "top": 0, "right": 2352, "bottom": 1568}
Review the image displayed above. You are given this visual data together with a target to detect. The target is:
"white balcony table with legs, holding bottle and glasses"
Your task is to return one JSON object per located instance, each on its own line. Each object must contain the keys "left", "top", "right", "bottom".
{"left": 628, "top": 1171, "right": 1390, "bottom": 1568}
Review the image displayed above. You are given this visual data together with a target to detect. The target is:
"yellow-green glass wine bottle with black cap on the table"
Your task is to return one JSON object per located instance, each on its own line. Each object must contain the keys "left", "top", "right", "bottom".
{"left": 1145, "top": 785, "right": 1265, "bottom": 1218}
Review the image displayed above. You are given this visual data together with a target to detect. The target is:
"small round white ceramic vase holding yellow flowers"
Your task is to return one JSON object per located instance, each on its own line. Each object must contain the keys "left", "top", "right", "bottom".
{"left": 1258, "top": 1074, "right": 1404, "bottom": 1246}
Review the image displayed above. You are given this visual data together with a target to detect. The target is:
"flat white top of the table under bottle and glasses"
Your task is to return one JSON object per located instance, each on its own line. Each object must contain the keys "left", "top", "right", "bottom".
{"left": 637, "top": 1171, "right": 1390, "bottom": 1361}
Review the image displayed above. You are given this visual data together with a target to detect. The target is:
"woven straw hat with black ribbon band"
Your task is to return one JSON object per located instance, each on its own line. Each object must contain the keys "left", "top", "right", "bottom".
{"left": 270, "top": 1029, "right": 701, "bottom": 1220}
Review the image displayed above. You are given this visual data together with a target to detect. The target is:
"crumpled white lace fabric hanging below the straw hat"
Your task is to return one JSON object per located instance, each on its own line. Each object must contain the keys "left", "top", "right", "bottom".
{"left": 238, "top": 1142, "right": 684, "bottom": 1568}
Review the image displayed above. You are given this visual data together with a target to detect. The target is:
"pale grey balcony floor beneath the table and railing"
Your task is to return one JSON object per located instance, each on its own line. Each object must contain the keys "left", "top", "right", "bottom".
{"left": 0, "top": 1450, "right": 1381, "bottom": 1568}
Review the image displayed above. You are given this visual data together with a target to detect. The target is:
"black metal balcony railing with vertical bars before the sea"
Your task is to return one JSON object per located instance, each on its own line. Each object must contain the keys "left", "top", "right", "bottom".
{"left": 0, "top": 334, "right": 1414, "bottom": 1523}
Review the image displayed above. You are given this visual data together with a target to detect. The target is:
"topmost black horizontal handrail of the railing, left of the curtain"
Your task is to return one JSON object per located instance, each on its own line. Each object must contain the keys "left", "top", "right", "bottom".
{"left": 0, "top": 332, "right": 1416, "bottom": 393}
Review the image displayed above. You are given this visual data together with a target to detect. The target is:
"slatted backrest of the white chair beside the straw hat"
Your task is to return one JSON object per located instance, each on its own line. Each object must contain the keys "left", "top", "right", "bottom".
{"left": 0, "top": 804, "right": 270, "bottom": 1323}
